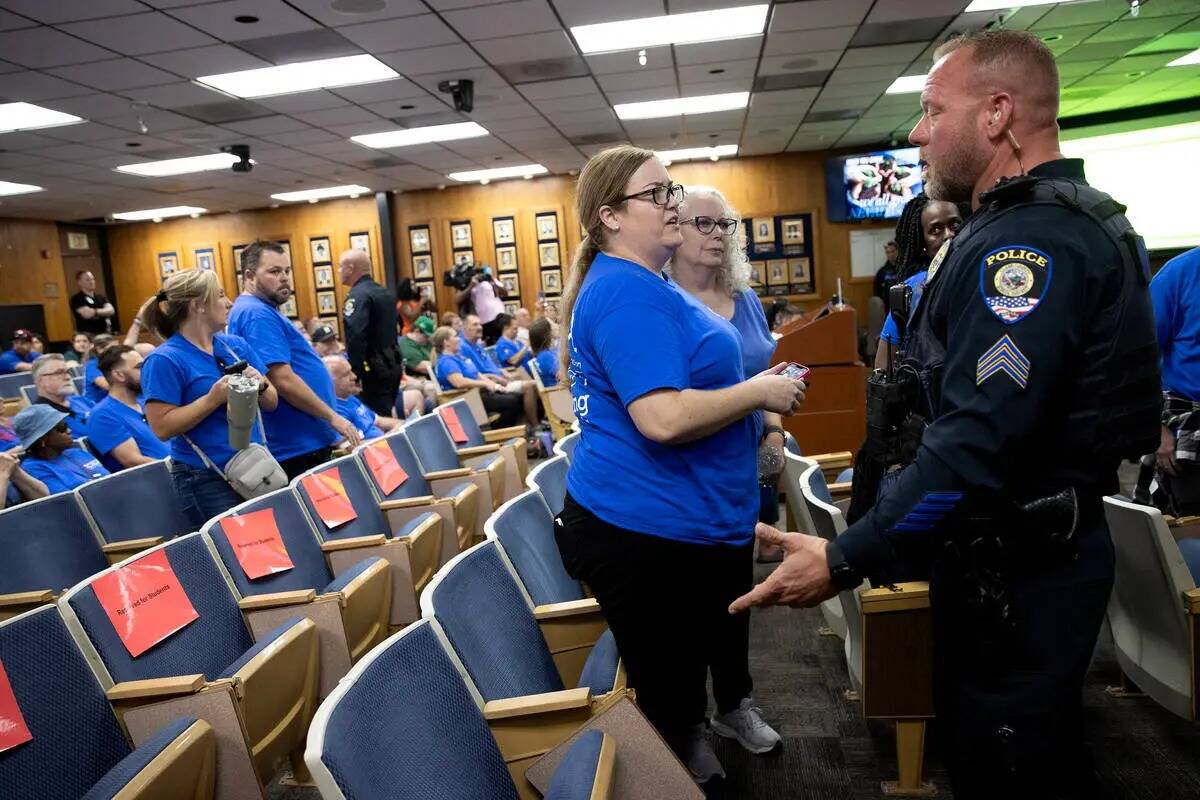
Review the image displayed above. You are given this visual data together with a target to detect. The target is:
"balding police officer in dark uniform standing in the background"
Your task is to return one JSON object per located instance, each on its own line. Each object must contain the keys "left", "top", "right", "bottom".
{"left": 338, "top": 249, "right": 402, "bottom": 416}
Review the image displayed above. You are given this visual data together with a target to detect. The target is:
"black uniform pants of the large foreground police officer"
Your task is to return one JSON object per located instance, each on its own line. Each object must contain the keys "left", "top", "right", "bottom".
{"left": 930, "top": 513, "right": 1114, "bottom": 800}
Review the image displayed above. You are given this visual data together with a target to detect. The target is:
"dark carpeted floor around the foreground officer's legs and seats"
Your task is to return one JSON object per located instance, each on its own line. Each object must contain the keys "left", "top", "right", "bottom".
{"left": 270, "top": 556, "right": 1200, "bottom": 800}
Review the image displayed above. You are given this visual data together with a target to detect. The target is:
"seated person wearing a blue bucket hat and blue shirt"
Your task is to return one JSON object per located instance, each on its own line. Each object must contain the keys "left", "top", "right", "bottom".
{"left": 12, "top": 405, "right": 109, "bottom": 494}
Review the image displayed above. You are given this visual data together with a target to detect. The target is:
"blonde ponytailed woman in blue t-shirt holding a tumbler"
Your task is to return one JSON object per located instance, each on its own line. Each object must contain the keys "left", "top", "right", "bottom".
{"left": 138, "top": 270, "right": 278, "bottom": 529}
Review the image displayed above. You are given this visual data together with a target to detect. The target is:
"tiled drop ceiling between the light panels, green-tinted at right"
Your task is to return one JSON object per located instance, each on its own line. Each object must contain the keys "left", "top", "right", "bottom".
{"left": 0, "top": 0, "right": 1200, "bottom": 219}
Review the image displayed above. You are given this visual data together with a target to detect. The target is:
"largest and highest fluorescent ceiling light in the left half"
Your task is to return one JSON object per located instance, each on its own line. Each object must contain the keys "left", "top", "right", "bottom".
{"left": 196, "top": 55, "right": 400, "bottom": 97}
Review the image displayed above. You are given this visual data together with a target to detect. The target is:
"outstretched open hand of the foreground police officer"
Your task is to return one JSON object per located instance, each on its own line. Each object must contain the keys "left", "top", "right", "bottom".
{"left": 730, "top": 522, "right": 838, "bottom": 614}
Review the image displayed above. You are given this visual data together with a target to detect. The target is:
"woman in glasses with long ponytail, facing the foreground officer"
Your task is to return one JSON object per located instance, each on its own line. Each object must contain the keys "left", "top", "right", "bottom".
{"left": 556, "top": 145, "right": 804, "bottom": 782}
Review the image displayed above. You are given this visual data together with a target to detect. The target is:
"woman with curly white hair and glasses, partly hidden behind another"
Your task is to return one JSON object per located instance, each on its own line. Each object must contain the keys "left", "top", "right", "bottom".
{"left": 666, "top": 186, "right": 784, "bottom": 753}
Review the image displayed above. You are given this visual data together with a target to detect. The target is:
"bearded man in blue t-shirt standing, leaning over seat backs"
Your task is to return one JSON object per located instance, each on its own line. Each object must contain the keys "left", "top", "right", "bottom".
{"left": 226, "top": 241, "right": 361, "bottom": 479}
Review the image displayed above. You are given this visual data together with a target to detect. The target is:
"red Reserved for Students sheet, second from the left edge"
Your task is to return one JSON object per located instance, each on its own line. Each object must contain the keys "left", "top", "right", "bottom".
{"left": 91, "top": 551, "right": 200, "bottom": 658}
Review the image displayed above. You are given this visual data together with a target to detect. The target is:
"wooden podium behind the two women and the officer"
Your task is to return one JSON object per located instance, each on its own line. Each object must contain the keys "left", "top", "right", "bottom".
{"left": 772, "top": 306, "right": 866, "bottom": 455}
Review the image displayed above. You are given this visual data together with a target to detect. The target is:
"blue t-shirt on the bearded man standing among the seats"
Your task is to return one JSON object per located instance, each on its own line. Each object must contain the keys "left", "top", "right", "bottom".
{"left": 227, "top": 294, "right": 342, "bottom": 461}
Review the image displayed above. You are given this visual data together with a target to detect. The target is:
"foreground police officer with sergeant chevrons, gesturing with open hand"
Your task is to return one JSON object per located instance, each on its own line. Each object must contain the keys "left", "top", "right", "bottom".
{"left": 731, "top": 30, "right": 1159, "bottom": 799}
